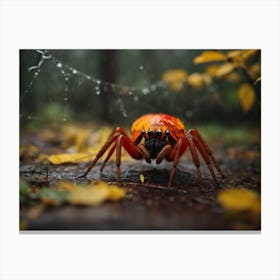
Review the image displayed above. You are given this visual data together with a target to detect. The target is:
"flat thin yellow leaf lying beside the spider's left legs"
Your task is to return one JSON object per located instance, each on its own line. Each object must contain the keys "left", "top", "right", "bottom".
{"left": 48, "top": 153, "right": 93, "bottom": 165}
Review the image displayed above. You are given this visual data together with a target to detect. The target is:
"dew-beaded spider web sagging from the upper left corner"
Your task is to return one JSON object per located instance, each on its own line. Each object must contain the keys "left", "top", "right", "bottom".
{"left": 20, "top": 50, "right": 173, "bottom": 125}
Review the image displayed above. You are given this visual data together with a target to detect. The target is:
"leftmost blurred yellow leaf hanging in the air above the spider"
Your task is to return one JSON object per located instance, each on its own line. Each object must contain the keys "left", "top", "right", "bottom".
{"left": 162, "top": 69, "right": 188, "bottom": 92}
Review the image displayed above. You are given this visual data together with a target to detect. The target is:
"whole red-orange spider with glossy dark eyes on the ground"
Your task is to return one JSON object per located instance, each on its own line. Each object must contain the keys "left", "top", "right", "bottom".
{"left": 81, "top": 114, "right": 224, "bottom": 187}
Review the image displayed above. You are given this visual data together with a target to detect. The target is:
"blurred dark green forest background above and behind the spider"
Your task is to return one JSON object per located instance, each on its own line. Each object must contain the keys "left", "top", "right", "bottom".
{"left": 20, "top": 50, "right": 261, "bottom": 127}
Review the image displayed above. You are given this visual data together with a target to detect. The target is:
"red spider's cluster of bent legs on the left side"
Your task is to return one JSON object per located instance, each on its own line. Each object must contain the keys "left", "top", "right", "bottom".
{"left": 79, "top": 127, "right": 142, "bottom": 183}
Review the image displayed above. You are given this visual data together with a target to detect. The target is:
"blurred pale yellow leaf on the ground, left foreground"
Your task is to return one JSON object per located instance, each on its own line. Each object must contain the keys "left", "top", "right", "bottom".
{"left": 68, "top": 181, "right": 125, "bottom": 206}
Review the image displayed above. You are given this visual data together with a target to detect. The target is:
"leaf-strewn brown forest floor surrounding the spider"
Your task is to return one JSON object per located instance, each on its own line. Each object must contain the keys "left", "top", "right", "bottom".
{"left": 20, "top": 125, "right": 261, "bottom": 231}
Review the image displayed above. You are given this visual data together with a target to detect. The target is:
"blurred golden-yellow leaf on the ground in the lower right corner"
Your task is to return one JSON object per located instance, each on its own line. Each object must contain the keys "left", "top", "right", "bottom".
{"left": 217, "top": 188, "right": 261, "bottom": 213}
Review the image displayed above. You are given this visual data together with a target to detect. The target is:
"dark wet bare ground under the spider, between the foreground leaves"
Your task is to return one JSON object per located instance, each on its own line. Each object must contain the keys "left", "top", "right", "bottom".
{"left": 20, "top": 153, "right": 261, "bottom": 230}
